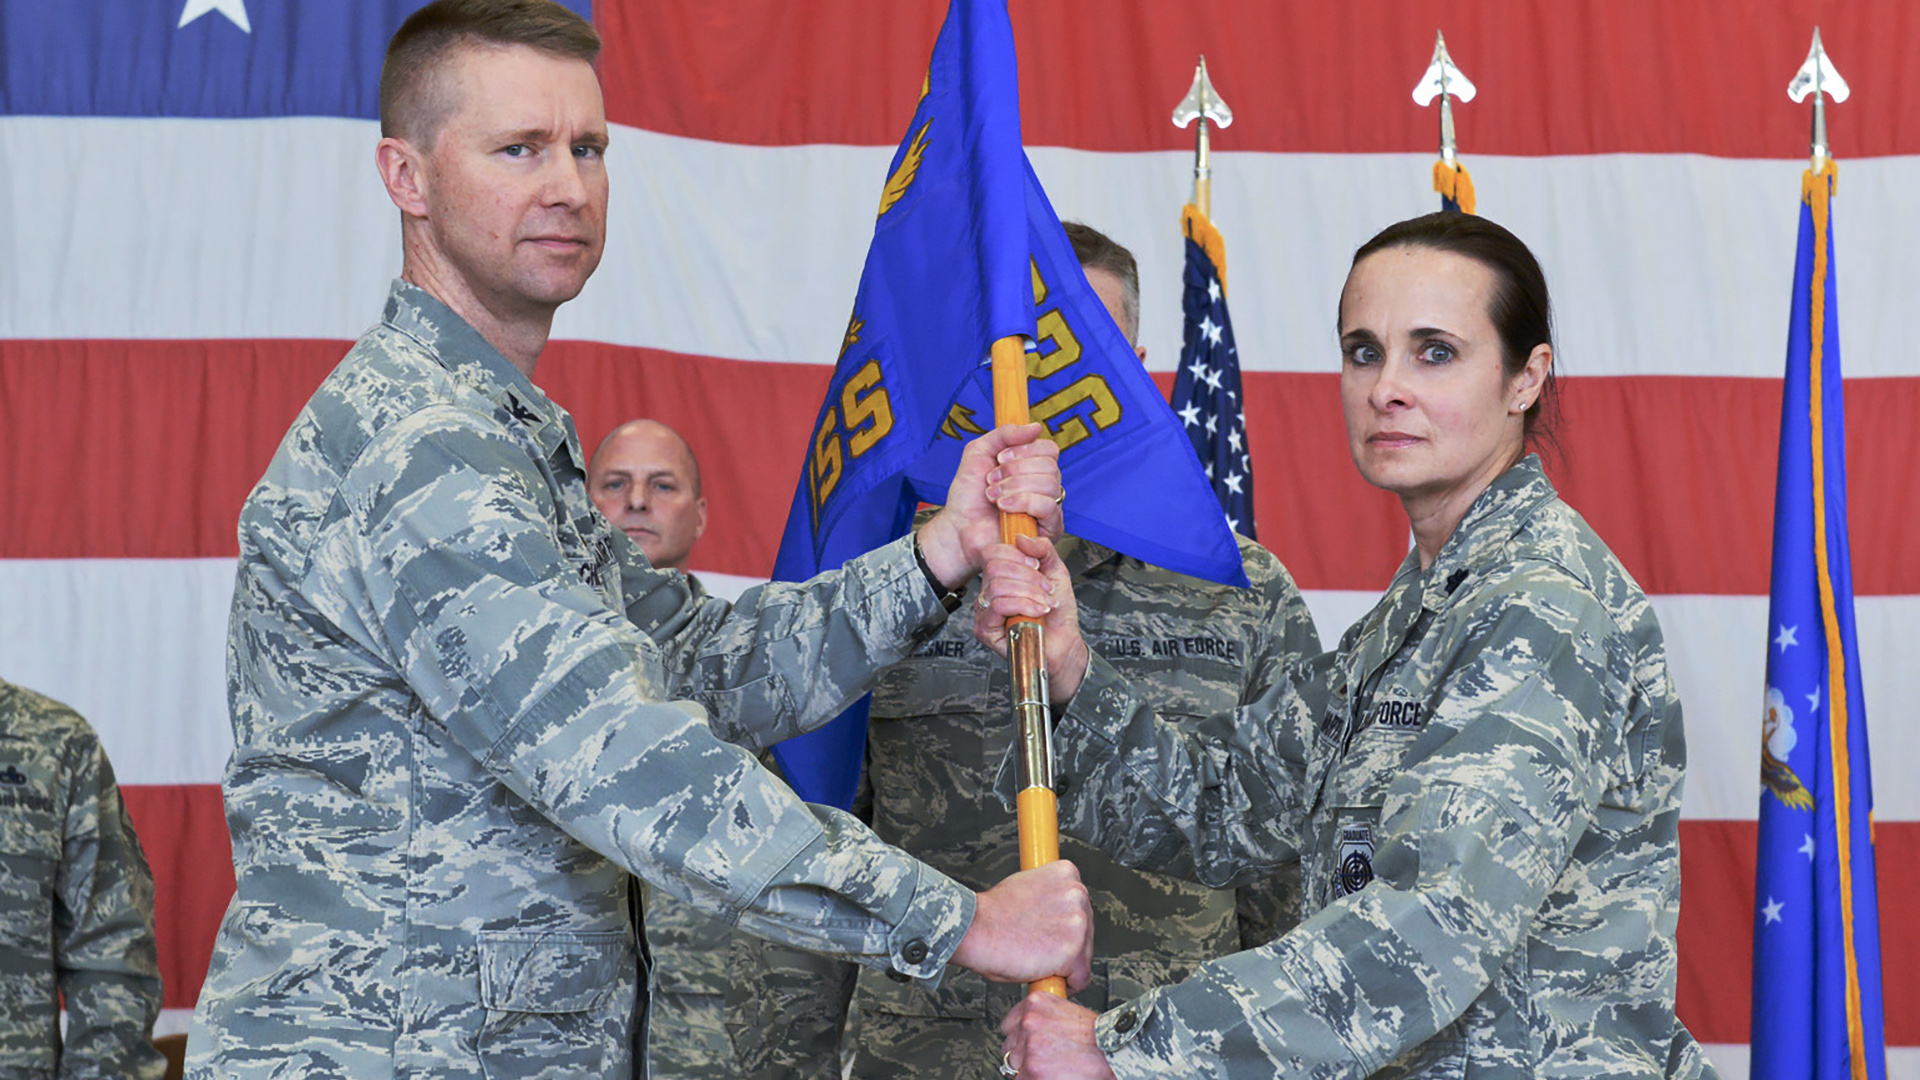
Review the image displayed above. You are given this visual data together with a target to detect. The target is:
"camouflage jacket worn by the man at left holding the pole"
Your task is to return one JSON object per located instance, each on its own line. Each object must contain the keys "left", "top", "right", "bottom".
{"left": 188, "top": 282, "right": 973, "bottom": 1080}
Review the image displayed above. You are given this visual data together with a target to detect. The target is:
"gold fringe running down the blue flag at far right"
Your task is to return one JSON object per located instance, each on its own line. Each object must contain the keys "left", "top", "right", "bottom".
{"left": 1801, "top": 158, "right": 1866, "bottom": 1080}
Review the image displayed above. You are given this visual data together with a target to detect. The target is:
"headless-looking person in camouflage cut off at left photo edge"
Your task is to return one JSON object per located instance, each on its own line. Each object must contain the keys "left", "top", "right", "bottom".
{"left": 0, "top": 680, "right": 167, "bottom": 1080}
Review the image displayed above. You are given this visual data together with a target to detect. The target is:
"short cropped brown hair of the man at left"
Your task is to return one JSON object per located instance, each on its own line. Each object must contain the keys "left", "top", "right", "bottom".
{"left": 380, "top": 0, "right": 601, "bottom": 146}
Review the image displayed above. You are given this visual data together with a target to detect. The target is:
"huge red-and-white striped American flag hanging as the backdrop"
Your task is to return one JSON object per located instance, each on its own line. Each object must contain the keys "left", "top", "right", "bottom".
{"left": 0, "top": 0, "right": 1920, "bottom": 1076}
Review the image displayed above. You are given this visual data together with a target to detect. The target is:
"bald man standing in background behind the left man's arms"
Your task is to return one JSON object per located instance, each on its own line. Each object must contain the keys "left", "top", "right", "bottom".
{"left": 588, "top": 419, "right": 733, "bottom": 1080}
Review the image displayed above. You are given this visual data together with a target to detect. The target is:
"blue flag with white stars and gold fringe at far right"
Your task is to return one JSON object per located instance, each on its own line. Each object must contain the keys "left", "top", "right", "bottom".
{"left": 1753, "top": 161, "right": 1887, "bottom": 1080}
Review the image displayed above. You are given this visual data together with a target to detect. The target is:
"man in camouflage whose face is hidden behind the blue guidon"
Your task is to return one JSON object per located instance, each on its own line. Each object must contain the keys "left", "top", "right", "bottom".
{"left": 728, "top": 221, "right": 1321, "bottom": 1080}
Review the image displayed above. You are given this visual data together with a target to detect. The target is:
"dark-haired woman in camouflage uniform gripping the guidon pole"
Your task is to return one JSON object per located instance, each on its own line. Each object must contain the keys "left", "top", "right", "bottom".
{"left": 975, "top": 213, "right": 1713, "bottom": 1080}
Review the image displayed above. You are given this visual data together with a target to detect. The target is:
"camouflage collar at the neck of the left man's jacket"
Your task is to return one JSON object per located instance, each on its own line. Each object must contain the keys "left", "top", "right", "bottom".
{"left": 380, "top": 277, "right": 586, "bottom": 473}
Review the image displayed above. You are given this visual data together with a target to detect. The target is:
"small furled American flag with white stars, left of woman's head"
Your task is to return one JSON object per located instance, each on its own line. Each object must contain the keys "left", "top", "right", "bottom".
{"left": 1173, "top": 204, "right": 1260, "bottom": 540}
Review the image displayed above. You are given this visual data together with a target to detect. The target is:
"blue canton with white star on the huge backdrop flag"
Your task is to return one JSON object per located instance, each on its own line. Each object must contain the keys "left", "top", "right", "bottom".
{"left": 0, "top": 0, "right": 591, "bottom": 119}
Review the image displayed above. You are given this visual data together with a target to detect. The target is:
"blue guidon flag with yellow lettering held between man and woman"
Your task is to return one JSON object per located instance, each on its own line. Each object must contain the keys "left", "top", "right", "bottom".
{"left": 774, "top": 0, "right": 1246, "bottom": 807}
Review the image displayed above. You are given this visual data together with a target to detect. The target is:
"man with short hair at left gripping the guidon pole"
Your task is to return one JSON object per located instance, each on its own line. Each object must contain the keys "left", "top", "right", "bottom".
{"left": 188, "top": 0, "right": 1092, "bottom": 1080}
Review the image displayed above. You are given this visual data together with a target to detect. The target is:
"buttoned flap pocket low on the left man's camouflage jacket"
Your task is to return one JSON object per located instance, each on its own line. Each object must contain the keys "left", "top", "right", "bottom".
{"left": 476, "top": 932, "right": 639, "bottom": 1080}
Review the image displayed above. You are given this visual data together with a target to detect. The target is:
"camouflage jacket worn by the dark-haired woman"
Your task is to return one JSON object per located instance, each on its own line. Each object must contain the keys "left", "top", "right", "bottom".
{"left": 1000, "top": 457, "right": 1711, "bottom": 1078}
